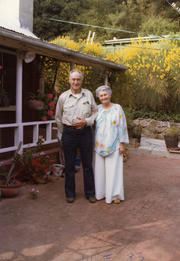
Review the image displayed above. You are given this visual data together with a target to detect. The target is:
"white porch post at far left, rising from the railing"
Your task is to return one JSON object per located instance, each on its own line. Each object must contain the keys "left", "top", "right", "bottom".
{"left": 14, "top": 53, "right": 23, "bottom": 150}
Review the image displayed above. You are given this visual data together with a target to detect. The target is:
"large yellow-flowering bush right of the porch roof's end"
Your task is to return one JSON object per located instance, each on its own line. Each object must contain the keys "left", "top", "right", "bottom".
{"left": 107, "top": 40, "right": 180, "bottom": 112}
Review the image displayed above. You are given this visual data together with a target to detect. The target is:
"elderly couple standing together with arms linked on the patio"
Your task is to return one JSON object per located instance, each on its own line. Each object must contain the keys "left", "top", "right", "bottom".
{"left": 56, "top": 69, "right": 129, "bottom": 203}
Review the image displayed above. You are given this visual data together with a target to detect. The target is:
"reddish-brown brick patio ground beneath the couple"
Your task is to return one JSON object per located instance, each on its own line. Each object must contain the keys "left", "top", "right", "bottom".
{"left": 0, "top": 153, "right": 180, "bottom": 261}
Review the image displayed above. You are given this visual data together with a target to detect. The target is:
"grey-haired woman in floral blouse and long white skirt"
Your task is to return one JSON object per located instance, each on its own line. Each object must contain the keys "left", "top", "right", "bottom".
{"left": 94, "top": 86, "right": 129, "bottom": 204}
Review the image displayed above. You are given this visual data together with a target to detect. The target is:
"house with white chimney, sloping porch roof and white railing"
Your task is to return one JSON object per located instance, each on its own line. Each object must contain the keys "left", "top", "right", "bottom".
{"left": 0, "top": 0, "right": 128, "bottom": 159}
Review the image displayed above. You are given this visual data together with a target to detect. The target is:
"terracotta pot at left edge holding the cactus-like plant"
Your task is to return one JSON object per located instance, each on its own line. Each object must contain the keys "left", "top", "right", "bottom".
{"left": 0, "top": 181, "right": 22, "bottom": 198}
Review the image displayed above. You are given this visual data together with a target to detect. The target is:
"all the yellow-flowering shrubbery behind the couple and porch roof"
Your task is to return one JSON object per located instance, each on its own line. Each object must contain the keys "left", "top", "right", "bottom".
{"left": 45, "top": 37, "right": 180, "bottom": 113}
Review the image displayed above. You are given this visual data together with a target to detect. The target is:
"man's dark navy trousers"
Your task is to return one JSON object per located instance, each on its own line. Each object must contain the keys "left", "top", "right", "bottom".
{"left": 62, "top": 126, "right": 95, "bottom": 198}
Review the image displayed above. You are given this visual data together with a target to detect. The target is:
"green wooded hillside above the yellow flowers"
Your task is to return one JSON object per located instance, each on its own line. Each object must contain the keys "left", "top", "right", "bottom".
{"left": 34, "top": 0, "right": 180, "bottom": 42}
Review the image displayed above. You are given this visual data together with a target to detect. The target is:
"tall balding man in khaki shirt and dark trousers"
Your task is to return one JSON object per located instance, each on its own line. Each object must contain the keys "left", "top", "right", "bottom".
{"left": 56, "top": 69, "right": 97, "bottom": 203}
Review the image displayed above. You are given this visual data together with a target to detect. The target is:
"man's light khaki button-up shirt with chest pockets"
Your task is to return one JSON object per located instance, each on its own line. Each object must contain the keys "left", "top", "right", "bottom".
{"left": 55, "top": 89, "right": 97, "bottom": 134}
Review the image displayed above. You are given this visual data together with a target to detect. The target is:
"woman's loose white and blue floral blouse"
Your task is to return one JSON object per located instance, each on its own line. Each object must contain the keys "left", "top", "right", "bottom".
{"left": 95, "top": 104, "right": 129, "bottom": 156}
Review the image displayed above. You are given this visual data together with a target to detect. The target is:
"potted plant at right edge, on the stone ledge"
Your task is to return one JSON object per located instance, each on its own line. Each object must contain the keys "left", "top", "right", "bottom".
{"left": 164, "top": 126, "right": 180, "bottom": 150}
